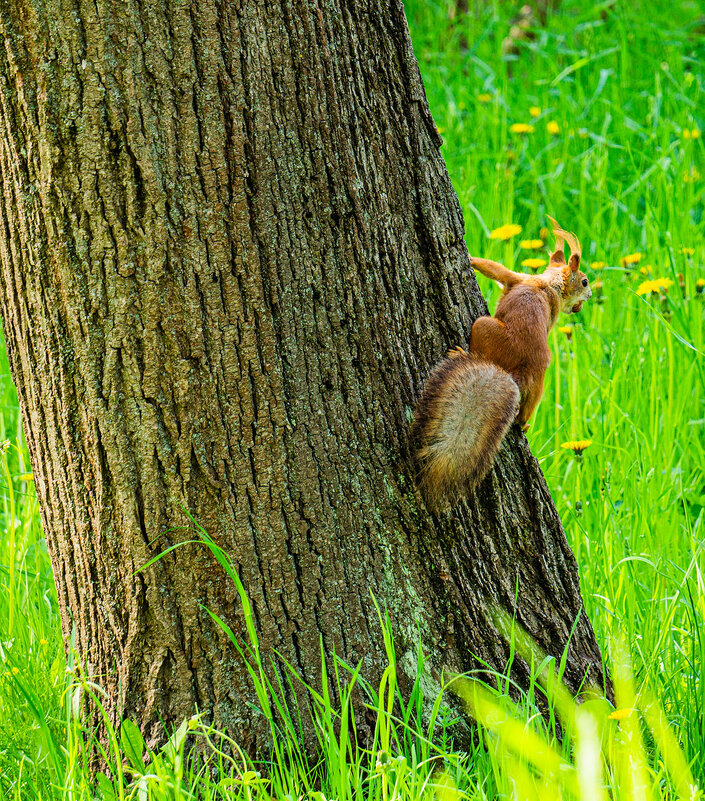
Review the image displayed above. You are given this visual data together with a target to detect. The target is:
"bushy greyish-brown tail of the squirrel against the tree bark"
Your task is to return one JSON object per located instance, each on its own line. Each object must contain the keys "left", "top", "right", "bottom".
{"left": 413, "top": 350, "right": 519, "bottom": 507}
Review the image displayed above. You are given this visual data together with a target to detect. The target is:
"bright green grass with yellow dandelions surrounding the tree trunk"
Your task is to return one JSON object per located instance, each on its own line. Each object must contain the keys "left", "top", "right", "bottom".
{"left": 0, "top": 0, "right": 705, "bottom": 801}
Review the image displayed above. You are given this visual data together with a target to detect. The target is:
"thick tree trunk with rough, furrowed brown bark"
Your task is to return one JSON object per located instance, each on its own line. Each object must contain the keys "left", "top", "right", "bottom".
{"left": 0, "top": 0, "right": 601, "bottom": 748}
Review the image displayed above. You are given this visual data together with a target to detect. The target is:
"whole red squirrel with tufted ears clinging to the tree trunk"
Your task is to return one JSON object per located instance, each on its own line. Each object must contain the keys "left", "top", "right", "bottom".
{"left": 413, "top": 217, "right": 592, "bottom": 507}
